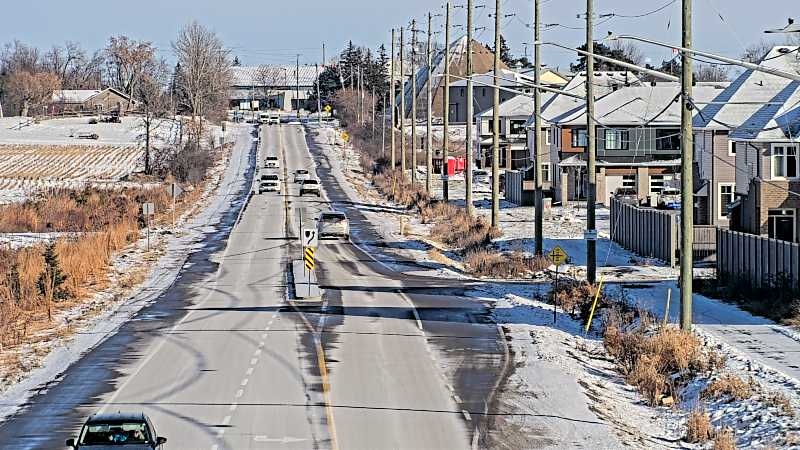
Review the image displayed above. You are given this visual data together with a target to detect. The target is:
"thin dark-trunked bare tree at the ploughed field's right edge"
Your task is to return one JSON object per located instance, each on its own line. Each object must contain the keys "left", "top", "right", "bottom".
{"left": 134, "top": 60, "right": 171, "bottom": 175}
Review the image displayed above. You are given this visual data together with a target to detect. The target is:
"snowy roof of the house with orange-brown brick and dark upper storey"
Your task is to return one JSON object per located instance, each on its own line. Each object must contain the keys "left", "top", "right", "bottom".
{"left": 558, "top": 82, "right": 727, "bottom": 126}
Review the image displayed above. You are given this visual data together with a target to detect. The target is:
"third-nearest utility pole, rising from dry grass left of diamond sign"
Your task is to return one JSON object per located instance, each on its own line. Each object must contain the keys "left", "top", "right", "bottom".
{"left": 533, "top": 0, "right": 544, "bottom": 256}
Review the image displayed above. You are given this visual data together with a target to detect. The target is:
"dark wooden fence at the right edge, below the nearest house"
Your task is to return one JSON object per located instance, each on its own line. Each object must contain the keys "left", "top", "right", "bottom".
{"left": 717, "top": 229, "right": 800, "bottom": 287}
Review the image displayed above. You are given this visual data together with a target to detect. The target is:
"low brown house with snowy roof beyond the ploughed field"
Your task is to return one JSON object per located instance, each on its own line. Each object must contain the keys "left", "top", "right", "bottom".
{"left": 48, "top": 88, "right": 138, "bottom": 114}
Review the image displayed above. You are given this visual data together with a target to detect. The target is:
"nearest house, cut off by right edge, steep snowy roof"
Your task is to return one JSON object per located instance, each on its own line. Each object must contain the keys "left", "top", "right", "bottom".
{"left": 695, "top": 46, "right": 800, "bottom": 242}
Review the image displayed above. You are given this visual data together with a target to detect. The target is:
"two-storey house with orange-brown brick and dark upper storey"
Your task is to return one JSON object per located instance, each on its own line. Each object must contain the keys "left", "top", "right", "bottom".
{"left": 551, "top": 82, "right": 727, "bottom": 205}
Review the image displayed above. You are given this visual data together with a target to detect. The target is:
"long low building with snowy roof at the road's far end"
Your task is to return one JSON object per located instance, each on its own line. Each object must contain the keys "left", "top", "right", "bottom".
{"left": 228, "top": 65, "right": 317, "bottom": 111}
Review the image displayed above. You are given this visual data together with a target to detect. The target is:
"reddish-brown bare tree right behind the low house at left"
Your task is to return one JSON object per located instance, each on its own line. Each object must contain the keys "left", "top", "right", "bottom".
{"left": 105, "top": 36, "right": 156, "bottom": 109}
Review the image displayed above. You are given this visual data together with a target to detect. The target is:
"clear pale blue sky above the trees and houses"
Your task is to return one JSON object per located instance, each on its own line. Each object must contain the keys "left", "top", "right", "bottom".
{"left": 0, "top": 0, "right": 800, "bottom": 71}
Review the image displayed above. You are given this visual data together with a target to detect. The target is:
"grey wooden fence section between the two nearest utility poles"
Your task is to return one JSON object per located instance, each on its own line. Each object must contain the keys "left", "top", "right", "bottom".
{"left": 610, "top": 199, "right": 679, "bottom": 267}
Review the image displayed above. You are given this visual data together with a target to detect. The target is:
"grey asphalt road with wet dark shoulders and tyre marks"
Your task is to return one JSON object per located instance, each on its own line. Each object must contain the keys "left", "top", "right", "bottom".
{"left": 0, "top": 121, "right": 507, "bottom": 450}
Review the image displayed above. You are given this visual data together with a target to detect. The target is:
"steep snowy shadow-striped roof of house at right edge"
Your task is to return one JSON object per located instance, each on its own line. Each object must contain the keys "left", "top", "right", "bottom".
{"left": 694, "top": 46, "right": 800, "bottom": 141}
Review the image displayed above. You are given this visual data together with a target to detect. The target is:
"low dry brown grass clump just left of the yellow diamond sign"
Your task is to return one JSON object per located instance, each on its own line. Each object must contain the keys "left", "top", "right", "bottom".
{"left": 464, "top": 249, "right": 550, "bottom": 278}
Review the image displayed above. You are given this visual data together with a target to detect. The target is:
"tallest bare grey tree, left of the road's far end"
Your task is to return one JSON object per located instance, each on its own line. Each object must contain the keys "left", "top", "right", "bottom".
{"left": 172, "top": 22, "right": 231, "bottom": 148}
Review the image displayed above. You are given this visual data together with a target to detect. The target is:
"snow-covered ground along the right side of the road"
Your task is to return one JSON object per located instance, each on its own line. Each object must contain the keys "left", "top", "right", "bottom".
{"left": 310, "top": 122, "right": 800, "bottom": 449}
